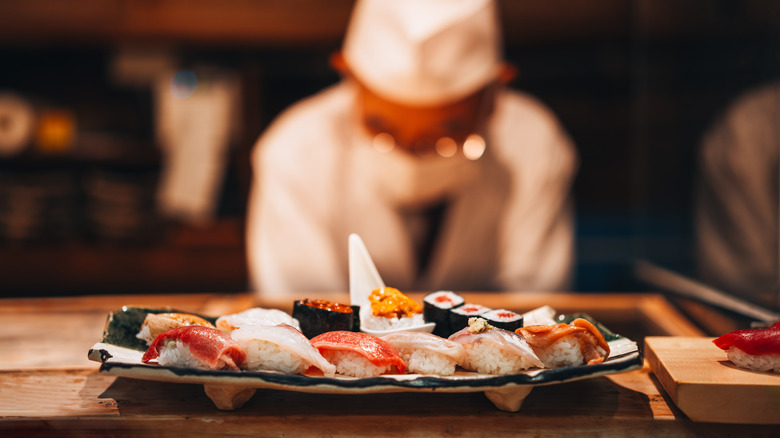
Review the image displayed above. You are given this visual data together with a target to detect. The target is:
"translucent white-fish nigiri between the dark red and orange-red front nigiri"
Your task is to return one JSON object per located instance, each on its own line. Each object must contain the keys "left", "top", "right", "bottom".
{"left": 230, "top": 323, "right": 336, "bottom": 377}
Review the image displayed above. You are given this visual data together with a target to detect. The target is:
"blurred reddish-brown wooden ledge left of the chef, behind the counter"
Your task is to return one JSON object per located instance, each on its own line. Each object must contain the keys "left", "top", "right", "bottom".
{"left": 0, "top": 220, "right": 248, "bottom": 297}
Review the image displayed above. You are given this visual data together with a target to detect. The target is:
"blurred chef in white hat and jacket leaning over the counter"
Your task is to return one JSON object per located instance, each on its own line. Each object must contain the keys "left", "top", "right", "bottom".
{"left": 247, "top": 0, "right": 577, "bottom": 298}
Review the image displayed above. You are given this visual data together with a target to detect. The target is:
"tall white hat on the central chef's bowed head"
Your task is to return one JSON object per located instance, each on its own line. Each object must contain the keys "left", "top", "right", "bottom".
{"left": 343, "top": 0, "right": 501, "bottom": 106}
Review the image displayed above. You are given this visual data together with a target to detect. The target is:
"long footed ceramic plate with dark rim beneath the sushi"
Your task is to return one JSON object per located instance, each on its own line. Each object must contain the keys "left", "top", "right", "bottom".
{"left": 89, "top": 307, "right": 642, "bottom": 411}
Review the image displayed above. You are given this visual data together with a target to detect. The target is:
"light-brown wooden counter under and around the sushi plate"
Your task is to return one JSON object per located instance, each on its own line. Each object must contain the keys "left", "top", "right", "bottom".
{"left": 0, "top": 293, "right": 776, "bottom": 437}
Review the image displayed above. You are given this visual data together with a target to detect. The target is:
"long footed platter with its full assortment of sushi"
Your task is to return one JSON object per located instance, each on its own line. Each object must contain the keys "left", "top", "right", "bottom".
{"left": 89, "top": 235, "right": 642, "bottom": 412}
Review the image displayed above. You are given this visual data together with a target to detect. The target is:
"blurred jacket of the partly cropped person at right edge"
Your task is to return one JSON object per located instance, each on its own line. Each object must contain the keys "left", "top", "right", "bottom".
{"left": 696, "top": 83, "right": 780, "bottom": 309}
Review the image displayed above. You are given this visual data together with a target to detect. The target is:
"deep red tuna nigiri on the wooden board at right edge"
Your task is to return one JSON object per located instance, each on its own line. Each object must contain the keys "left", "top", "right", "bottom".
{"left": 712, "top": 321, "right": 780, "bottom": 373}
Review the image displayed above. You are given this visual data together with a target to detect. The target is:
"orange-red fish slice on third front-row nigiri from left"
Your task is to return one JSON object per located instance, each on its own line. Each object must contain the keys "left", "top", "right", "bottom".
{"left": 311, "top": 331, "right": 406, "bottom": 374}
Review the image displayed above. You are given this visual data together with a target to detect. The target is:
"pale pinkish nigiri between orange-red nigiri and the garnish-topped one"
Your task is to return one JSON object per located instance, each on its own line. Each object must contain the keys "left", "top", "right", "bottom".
{"left": 382, "top": 331, "right": 466, "bottom": 376}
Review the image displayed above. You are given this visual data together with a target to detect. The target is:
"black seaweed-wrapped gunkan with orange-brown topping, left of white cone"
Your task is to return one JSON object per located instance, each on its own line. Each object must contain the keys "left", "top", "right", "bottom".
{"left": 293, "top": 298, "right": 355, "bottom": 339}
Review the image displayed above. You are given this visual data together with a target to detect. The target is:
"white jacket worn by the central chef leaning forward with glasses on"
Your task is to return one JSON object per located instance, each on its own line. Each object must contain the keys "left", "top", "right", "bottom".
{"left": 247, "top": 81, "right": 577, "bottom": 298}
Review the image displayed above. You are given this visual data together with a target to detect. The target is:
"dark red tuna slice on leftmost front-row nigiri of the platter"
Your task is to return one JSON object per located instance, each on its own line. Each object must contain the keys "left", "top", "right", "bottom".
{"left": 141, "top": 325, "right": 246, "bottom": 370}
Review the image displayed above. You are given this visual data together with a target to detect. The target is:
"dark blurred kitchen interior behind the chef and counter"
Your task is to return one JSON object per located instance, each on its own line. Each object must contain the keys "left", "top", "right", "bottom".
{"left": 0, "top": 0, "right": 780, "bottom": 296}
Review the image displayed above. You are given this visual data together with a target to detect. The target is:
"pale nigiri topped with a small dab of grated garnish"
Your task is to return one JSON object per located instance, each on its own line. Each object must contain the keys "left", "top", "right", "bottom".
{"left": 449, "top": 317, "right": 544, "bottom": 375}
